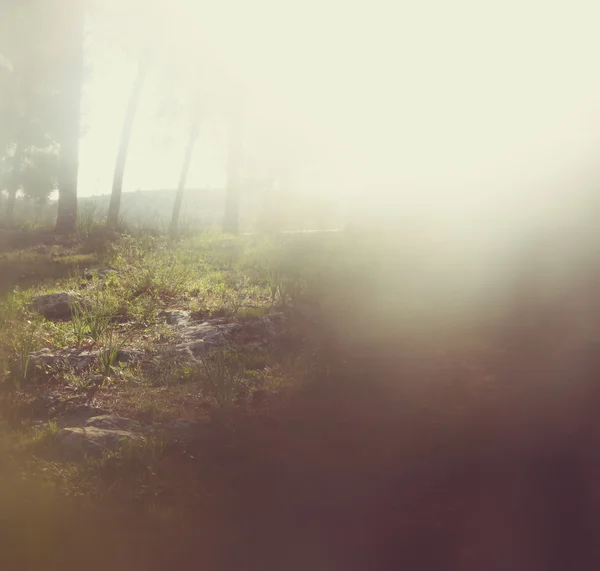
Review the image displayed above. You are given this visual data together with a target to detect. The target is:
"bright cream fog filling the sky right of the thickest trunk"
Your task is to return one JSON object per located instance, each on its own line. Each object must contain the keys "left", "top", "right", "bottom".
{"left": 7, "top": 0, "right": 600, "bottom": 236}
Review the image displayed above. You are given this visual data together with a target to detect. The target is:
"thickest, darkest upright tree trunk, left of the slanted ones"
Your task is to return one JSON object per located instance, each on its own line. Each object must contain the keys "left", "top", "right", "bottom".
{"left": 56, "top": 0, "right": 84, "bottom": 234}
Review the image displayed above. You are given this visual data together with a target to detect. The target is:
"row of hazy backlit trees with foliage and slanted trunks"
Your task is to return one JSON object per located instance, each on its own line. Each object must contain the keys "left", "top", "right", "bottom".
{"left": 0, "top": 0, "right": 243, "bottom": 235}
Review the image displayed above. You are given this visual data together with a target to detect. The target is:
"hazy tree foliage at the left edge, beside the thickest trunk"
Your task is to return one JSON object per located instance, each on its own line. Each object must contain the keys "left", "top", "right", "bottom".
{"left": 0, "top": 0, "right": 66, "bottom": 220}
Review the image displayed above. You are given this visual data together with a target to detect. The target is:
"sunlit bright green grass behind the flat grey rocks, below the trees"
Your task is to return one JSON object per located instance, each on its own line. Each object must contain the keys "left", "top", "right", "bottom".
{"left": 0, "top": 233, "right": 328, "bottom": 392}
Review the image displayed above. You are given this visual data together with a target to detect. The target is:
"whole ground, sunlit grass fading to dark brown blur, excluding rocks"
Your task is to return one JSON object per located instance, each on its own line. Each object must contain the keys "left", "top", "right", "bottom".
{"left": 0, "top": 230, "right": 600, "bottom": 571}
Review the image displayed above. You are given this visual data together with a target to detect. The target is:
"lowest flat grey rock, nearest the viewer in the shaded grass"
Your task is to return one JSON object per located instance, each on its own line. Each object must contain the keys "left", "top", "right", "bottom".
{"left": 54, "top": 426, "right": 143, "bottom": 461}
